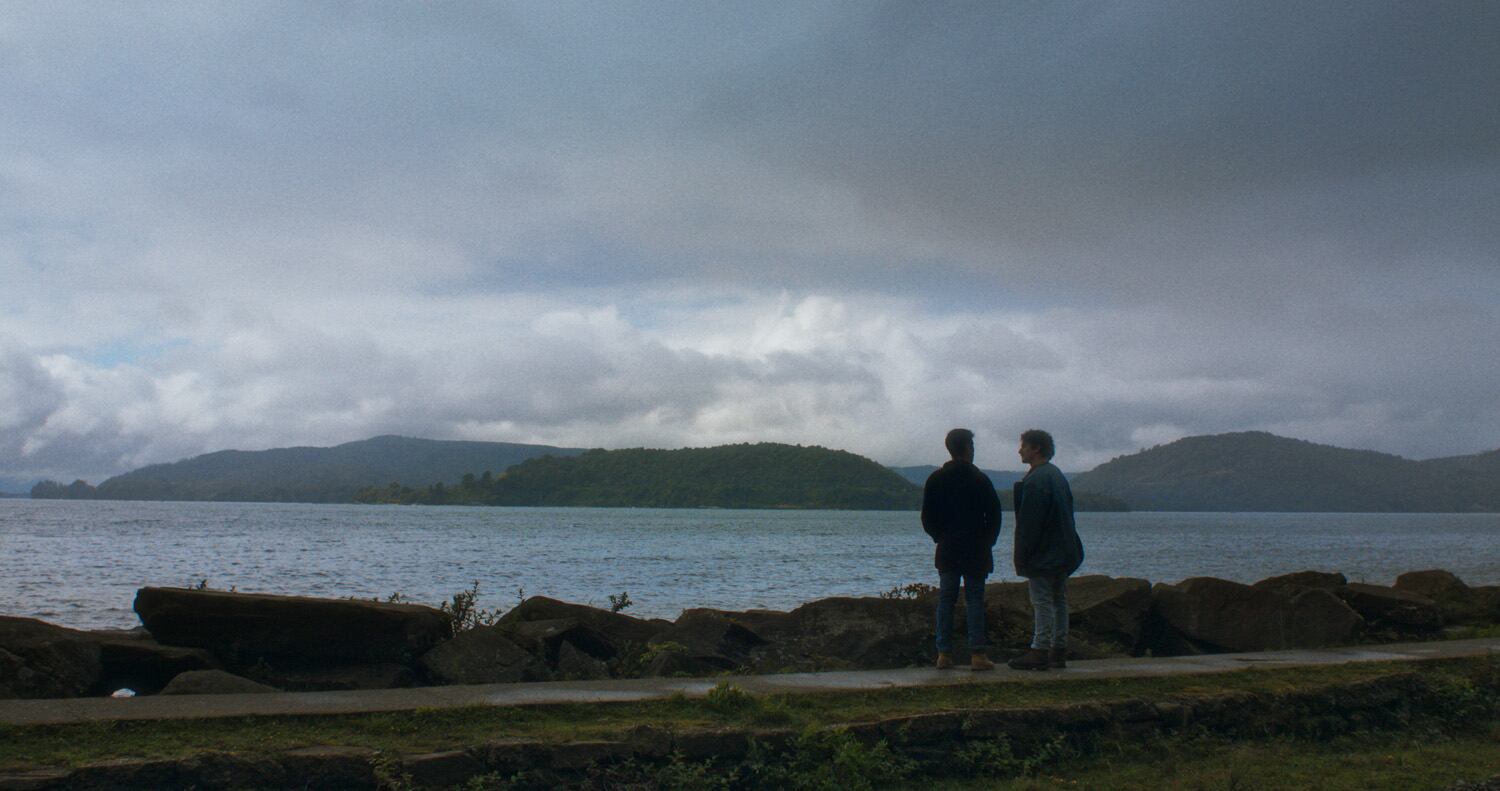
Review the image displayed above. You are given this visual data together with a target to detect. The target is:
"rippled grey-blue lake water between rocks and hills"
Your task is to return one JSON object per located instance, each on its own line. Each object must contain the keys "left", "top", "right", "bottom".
{"left": 0, "top": 500, "right": 1500, "bottom": 629}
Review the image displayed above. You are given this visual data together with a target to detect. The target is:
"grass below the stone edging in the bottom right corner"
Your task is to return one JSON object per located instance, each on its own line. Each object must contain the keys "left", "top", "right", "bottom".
{"left": 932, "top": 728, "right": 1500, "bottom": 791}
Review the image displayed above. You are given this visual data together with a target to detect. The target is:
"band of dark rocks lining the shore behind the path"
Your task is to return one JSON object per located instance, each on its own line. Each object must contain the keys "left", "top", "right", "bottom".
{"left": 0, "top": 570, "right": 1500, "bottom": 698}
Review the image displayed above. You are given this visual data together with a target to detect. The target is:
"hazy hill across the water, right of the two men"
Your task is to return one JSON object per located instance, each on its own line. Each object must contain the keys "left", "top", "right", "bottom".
{"left": 1073, "top": 431, "right": 1500, "bottom": 512}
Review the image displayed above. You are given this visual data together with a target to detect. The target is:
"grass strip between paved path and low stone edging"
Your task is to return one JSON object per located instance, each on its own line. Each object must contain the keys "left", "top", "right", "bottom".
{"left": 0, "top": 657, "right": 1500, "bottom": 771}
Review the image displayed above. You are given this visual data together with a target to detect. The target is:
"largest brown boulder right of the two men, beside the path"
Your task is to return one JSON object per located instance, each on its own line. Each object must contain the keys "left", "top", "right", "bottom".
{"left": 1148, "top": 576, "right": 1364, "bottom": 656}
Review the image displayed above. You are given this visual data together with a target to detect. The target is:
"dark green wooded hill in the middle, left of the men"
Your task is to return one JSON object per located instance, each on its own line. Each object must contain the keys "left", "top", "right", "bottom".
{"left": 360, "top": 443, "right": 921, "bottom": 510}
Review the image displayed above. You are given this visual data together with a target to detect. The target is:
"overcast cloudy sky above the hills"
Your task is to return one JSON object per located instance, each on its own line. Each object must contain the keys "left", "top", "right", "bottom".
{"left": 0, "top": 0, "right": 1500, "bottom": 489}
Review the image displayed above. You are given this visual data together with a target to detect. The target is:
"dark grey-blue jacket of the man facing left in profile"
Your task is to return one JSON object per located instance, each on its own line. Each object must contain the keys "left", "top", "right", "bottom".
{"left": 1014, "top": 461, "right": 1083, "bottom": 576}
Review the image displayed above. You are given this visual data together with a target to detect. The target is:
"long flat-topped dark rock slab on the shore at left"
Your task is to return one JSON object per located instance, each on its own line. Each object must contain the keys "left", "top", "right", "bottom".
{"left": 135, "top": 588, "right": 450, "bottom": 662}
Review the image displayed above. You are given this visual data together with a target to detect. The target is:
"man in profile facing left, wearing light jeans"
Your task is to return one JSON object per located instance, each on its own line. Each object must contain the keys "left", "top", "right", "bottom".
{"left": 1010, "top": 429, "right": 1083, "bottom": 669}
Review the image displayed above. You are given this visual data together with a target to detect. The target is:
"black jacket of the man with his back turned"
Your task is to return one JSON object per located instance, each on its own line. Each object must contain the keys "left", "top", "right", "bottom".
{"left": 923, "top": 459, "right": 1001, "bottom": 575}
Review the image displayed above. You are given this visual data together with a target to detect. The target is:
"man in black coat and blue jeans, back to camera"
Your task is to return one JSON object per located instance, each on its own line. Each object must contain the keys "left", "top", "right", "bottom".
{"left": 923, "top": 428, "right": 1001, "bottom": 669}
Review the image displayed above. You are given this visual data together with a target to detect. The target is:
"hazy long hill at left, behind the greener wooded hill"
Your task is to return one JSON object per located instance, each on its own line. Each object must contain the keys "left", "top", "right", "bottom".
{"left": 32, "top": 435, "right": 584, "bottom": 503}
